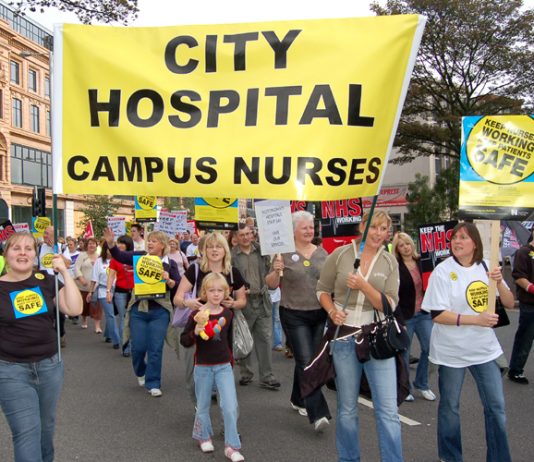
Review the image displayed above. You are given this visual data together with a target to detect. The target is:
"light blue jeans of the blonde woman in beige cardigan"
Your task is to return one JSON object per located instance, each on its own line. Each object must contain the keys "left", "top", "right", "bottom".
{"left": 333, "top": 337, "right": 403, "bottom": 462}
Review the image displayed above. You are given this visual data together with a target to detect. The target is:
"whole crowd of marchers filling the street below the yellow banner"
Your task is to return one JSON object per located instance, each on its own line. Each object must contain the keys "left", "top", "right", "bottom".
{"left": 0, "top": 216, "right": 534, "bottom": 462}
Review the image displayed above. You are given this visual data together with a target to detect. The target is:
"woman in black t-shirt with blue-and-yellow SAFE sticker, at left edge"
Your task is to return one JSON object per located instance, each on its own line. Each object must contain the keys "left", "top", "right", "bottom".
{"left": 0, "top": 233, "right": 82, "bottom": 462}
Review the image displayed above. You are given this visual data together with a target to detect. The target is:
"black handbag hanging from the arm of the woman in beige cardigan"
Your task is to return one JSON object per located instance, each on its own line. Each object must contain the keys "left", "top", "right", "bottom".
{"left": 369, "top": 294, "right": 410, "bottom": 359}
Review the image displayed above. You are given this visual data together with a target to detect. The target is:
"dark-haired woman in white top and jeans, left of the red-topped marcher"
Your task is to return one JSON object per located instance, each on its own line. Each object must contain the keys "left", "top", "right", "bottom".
{"left": 87, "top": 241, "right": 121, "bottom": 350}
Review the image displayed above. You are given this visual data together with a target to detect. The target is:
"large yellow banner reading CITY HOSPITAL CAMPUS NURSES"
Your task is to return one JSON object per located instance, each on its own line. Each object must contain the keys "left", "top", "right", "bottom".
{"left": 53, "top": 15, "right": 425, "bottom": 200}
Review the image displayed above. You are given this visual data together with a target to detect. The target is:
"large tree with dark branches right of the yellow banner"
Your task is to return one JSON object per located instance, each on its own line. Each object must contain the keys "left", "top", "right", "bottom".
{"left": 371, "top": 0, "right": 534, "bottom": 164}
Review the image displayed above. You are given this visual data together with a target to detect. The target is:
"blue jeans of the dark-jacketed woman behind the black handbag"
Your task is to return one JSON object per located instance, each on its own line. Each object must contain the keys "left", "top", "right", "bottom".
{"left": 403, "top": 311, "right": 432, "bottom": 390}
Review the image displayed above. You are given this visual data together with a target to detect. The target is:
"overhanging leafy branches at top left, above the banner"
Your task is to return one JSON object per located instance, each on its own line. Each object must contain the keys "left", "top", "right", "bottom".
{"left": 11, "top": 0, "right": 139, "bottom": 24}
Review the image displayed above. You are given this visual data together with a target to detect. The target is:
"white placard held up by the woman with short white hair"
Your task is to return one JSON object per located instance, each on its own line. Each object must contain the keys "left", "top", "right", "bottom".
{"left": 255, "top": 200, "right": 295, "bottom": 255}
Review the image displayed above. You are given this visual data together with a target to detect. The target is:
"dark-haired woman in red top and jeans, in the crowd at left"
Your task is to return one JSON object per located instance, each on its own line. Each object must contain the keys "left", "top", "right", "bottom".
{"left": 106, "top": 235, "right": 134, "bottom": 358}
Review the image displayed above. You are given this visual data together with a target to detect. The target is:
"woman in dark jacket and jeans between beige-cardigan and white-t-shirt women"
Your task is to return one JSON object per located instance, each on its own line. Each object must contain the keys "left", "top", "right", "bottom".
{"left": 393, "top": 233, "right": 436, "bottom": 401}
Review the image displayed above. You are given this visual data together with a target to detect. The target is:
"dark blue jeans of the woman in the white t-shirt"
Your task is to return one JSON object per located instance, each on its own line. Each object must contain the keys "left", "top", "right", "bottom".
{"left": 438, "top": 361, "right": 512, "bottom": 462}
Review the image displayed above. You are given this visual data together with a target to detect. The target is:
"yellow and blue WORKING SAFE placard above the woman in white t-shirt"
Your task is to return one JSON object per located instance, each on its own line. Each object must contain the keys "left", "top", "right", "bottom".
{"left": 459, "top": 115, "right": 534, "bottom": 220}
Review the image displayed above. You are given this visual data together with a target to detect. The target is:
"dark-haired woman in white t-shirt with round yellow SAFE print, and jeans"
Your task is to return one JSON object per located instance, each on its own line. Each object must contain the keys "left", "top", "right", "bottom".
{"left": 422, "top": 223, "right": 514, "bottom": 462}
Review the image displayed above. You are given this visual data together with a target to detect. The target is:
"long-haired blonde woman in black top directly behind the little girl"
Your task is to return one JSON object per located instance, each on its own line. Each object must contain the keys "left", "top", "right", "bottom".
{"left": 174, "top": 232, "right": 247, "bottom": 402}
